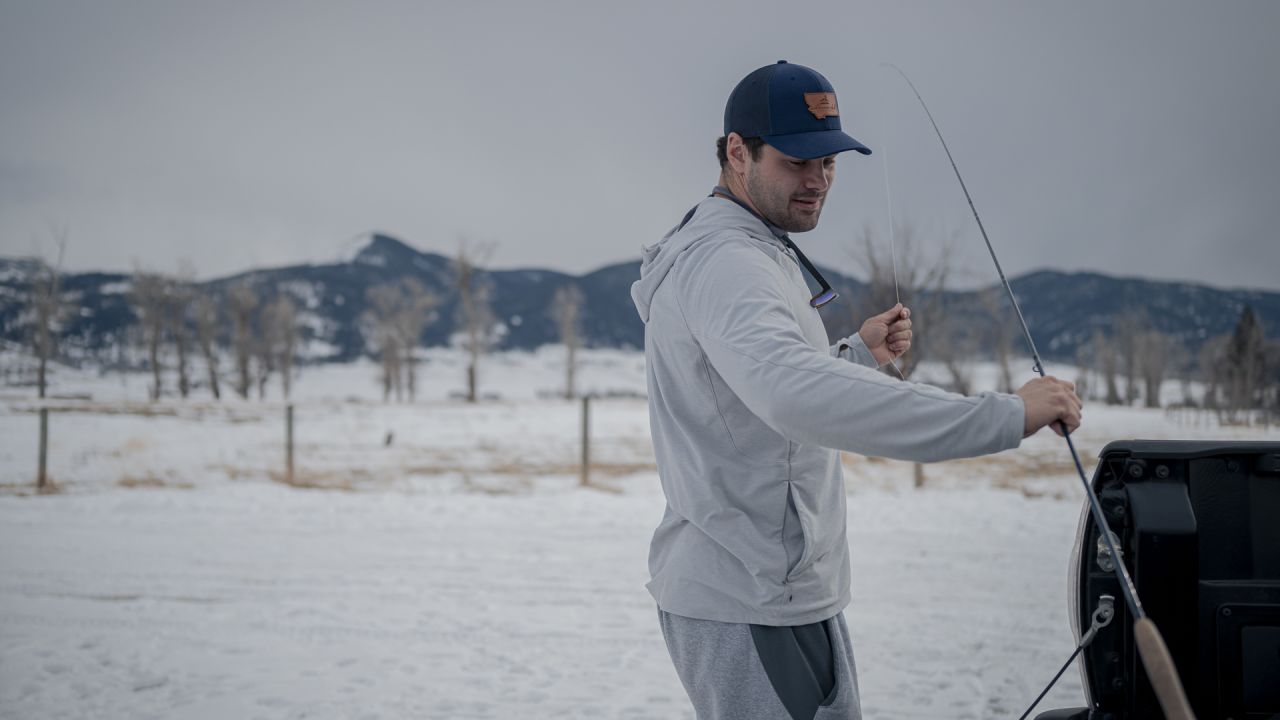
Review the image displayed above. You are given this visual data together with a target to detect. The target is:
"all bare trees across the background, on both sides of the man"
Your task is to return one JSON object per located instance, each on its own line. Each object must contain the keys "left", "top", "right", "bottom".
{"left": 22, "top": 224, "right": 1280, "bottom": 412}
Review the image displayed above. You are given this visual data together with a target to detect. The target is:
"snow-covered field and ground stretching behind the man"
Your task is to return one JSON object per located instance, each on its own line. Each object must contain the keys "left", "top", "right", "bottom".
{"left": 0, "top": 348, "right": 1280, "bottom": 720}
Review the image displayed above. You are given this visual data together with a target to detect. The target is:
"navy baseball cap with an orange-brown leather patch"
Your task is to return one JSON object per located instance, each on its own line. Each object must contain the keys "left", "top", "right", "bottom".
{"left": 724, "top": 60, "right": 872, "bottom": 160}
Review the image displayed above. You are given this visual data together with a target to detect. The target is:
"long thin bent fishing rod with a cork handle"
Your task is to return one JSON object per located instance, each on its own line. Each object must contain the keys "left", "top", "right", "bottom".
{"left": 881, "top": 63, "right": 1196, "bottom": 720}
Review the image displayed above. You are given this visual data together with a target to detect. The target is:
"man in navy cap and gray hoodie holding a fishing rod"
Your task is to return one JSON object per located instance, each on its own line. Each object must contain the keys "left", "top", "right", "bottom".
{"left": 631, "top": 61, "right": 1080, "bottom": 720}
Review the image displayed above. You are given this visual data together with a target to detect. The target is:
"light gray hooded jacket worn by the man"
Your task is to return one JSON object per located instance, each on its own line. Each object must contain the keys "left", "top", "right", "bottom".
{"left": 631, "top": 197, "right": 1024, "bottom": 625}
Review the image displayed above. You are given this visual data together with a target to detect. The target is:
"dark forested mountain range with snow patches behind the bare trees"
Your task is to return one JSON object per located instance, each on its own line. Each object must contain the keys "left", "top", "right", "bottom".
{"left": 0, "top": 234, "right": 1280, "bottom": 364}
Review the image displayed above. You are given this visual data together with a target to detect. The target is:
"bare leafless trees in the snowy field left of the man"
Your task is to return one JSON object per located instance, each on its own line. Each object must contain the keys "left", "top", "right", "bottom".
{"left": 20, "top": 237, "right": 584, "bottom": 402}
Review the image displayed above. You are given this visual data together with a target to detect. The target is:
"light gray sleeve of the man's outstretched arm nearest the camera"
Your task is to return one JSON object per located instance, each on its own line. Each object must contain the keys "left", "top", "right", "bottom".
{"left": 669, "top": 235, "right": 1024, "bottom": 462}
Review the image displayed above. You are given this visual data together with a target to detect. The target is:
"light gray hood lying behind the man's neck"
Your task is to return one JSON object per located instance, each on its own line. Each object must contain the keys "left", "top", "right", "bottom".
{"left": 631, "top": 196, "right": 782, "bottom": 323}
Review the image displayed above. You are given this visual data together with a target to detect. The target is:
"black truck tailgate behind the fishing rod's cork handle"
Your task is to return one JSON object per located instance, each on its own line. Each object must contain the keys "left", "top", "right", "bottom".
{"left": 1037, "top": 441, "right": 1280, "bottom": 720}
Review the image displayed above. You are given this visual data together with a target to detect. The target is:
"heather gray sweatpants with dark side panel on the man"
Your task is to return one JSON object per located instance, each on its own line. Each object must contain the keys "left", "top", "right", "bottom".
{"left": 658, "top": 609, "right": 863, "bottom": 720}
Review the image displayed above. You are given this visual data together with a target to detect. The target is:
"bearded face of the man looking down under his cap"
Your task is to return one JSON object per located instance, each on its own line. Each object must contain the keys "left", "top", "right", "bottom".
{"left": 744, "top": 143, "right": 836, "bottom": 232}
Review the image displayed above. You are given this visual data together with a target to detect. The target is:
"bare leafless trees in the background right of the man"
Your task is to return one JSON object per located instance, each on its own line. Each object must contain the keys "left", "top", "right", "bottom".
{"left": 850, "top": 224, "right": 1280, "bottom": 421}
